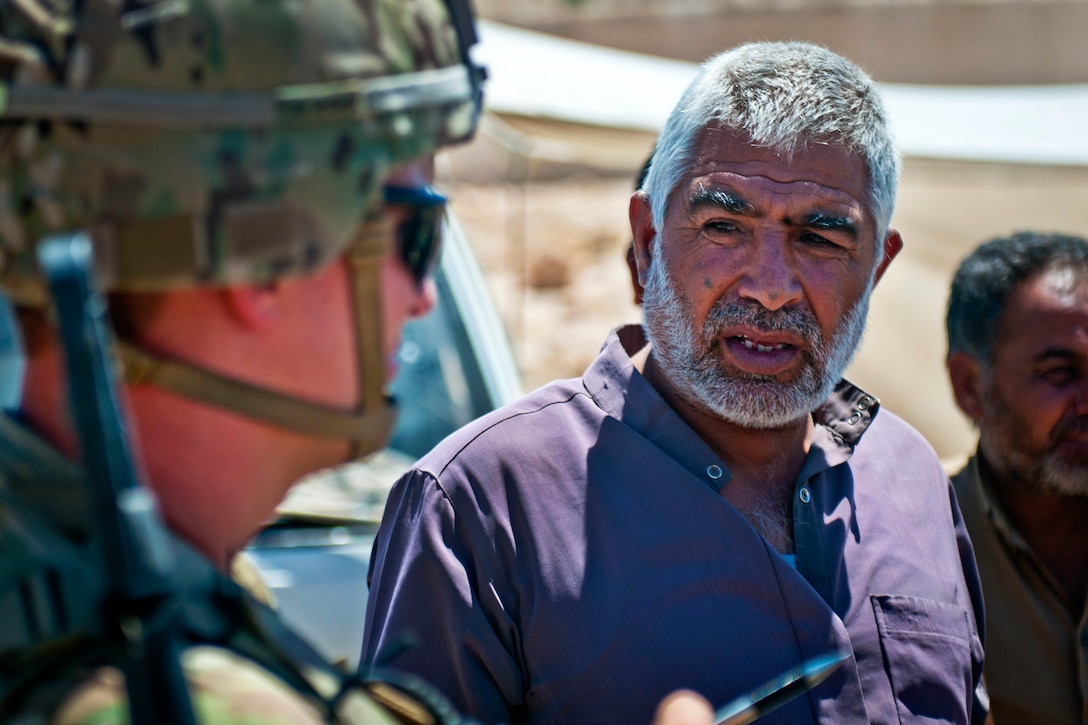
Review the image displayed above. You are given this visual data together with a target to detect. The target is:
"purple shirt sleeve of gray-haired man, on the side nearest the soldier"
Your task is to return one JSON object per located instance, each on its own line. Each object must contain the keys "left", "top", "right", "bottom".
{"left": 361, "top": 470, "right": 526, "bottom": 723}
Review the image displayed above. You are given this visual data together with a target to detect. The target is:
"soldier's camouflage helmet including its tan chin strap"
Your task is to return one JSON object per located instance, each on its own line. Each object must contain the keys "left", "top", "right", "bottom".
{"left": 0, "top": 0, "right": 483, "bottom": 455}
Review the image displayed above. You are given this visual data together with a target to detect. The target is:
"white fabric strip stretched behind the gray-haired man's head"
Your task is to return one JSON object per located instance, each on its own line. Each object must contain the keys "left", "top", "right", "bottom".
{"left": 477, "top": 21, "right": 1088, "bottom": 165}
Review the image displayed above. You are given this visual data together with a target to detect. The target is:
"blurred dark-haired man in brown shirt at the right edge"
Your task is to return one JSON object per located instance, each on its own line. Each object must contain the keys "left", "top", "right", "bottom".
{"left": 947, "top": 232, "right": 1088, "bottom": 725}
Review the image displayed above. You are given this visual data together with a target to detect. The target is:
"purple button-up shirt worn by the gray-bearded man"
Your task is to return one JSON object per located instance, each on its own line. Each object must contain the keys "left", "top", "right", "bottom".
{"left": 363, "top": 329, "right": 986, "bottom": 724}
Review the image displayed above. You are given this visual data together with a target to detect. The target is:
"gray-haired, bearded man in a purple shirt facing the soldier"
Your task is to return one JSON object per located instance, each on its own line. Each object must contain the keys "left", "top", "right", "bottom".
{"left": 363, "top": 44, "right": 986, "bottom": 723}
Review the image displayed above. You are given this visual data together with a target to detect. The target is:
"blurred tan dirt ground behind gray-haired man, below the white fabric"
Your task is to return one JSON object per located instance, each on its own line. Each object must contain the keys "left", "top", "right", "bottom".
{"left": 445, "top": 148, "right": 1088, "bottom": 459}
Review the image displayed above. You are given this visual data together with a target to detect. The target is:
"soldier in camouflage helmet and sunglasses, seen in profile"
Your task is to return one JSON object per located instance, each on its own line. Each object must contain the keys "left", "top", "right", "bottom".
{"left": 0, "top": 0, "right": 482, "bottom": 723}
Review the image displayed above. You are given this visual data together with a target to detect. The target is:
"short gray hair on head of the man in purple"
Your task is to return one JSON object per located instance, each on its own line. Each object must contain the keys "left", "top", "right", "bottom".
{"left": 642, "top": 42, "right": 900, "bottom": 243}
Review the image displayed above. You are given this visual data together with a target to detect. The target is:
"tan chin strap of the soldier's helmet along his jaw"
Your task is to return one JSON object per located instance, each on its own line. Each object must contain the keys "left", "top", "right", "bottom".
{"left": 118, "top": 219, "right": 396, "bottom": 457}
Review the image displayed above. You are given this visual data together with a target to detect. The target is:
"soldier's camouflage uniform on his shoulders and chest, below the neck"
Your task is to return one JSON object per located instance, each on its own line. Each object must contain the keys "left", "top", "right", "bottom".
{"left": 0, "top": 407, "right": 450, "bottom": 725}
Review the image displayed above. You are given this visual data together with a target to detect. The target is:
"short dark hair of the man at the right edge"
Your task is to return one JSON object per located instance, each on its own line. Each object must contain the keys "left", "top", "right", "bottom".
{"left": 944, "top": 232, "right": 1088, "bottom": 368}
